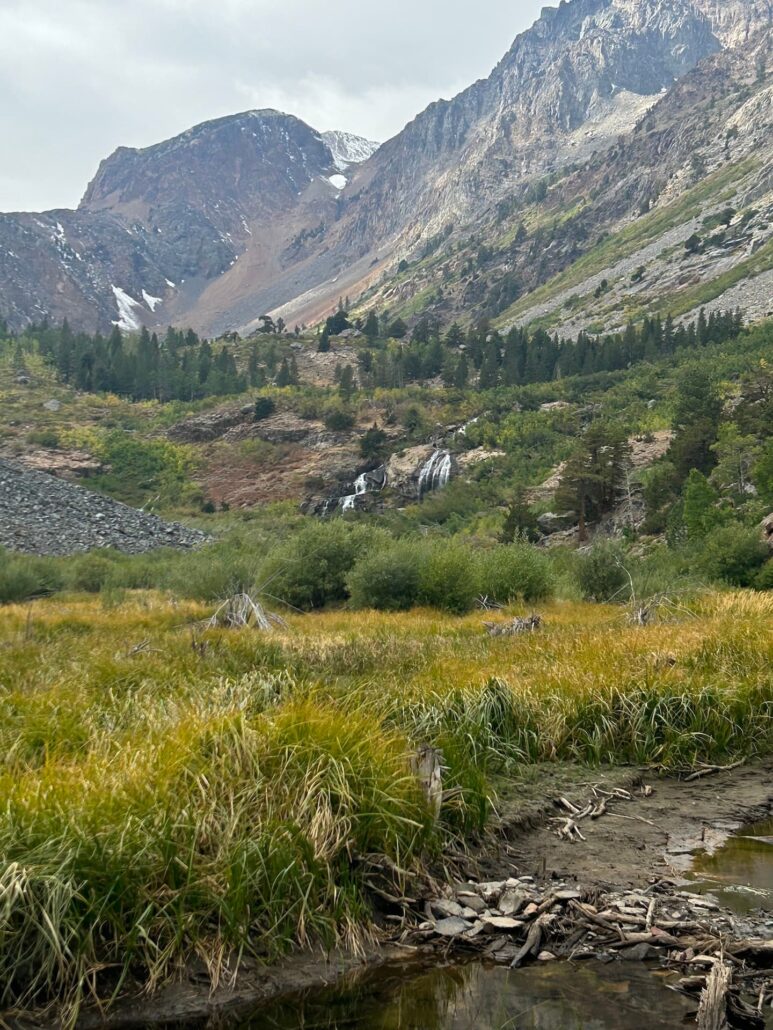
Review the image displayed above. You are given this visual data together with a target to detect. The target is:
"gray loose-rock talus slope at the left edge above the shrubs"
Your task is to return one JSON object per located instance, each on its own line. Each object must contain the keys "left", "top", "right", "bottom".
{"left": 0, "top": 460, "right": 206, "bottom": 560}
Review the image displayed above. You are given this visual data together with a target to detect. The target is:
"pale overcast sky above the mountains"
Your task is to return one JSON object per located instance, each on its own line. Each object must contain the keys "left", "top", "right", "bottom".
{"left": 0, "top": 0, "right": 545, "bottom": 211}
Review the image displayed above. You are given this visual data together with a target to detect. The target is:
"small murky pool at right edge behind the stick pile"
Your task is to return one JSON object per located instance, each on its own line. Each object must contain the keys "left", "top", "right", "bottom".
{"left": 692, "top": 819, "right": 773, "bottom": 914}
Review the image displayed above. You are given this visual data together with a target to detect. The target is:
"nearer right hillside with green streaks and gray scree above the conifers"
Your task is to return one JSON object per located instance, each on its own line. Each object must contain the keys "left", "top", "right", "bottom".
{"left": 361, "top": 27, "right": 773, "bottom": 336}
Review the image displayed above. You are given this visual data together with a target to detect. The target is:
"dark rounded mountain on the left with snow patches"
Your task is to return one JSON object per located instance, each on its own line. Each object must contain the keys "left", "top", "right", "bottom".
{"left": 0, "top": 110, "right": 376, "bottom": 332}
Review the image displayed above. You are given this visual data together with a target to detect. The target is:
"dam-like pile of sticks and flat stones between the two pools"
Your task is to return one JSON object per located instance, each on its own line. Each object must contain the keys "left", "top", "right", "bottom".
{"left": 395, "top": 877, "right": 773, "bottom": 1030}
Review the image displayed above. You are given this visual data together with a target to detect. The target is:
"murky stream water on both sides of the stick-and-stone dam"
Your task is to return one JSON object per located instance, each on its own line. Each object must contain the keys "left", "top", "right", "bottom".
{"left": 228, "top": 820, "right": 773, "bottom": 1030}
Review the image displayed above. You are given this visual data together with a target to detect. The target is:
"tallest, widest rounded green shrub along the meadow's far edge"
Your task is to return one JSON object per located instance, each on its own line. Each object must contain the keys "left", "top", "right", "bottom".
{"left": 261, "top": 519, "right": 391, "bottom": 611}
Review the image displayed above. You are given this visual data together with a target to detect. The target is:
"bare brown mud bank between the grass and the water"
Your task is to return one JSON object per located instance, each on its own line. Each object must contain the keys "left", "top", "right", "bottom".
{"left": 69, "top": 760, "right": 773, "bottom": 1030}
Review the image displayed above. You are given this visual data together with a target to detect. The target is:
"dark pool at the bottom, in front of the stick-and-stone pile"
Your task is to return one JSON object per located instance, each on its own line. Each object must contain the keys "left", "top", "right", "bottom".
{"left": 241, "top": 962, "right": 694, "bottom": 1030}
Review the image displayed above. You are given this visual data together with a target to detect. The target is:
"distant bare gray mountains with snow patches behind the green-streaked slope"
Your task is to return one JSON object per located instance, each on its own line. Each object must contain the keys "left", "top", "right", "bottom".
{"left": 0, "top": 0, "right": 773, "bottom": 333}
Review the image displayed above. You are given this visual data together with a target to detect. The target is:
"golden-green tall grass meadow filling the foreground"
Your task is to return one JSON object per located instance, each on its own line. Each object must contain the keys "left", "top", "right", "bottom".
{"left": 0, "top": 592, "right": 773, "bottom": 1018}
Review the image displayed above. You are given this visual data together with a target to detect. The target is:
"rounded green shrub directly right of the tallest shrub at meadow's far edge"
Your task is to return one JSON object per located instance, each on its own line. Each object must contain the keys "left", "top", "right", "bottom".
{"left": 346, "top": 542, "right": 419, "bottom": 612}
